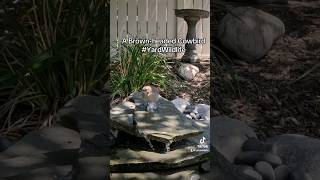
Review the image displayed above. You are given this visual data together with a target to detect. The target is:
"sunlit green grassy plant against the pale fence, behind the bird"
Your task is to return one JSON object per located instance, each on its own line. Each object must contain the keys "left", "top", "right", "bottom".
{"left": 111, "top": 44, "right": 170, "bottom": 97}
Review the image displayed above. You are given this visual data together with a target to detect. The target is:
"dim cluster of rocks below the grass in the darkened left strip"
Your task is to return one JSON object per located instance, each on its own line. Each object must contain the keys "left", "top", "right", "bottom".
{"left": 0, "top": 96, "right": 110, "bottom": 180}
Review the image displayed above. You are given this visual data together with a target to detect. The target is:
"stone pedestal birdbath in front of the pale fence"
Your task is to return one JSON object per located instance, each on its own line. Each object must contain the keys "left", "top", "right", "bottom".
{"left": 175, "top": 9, "right": 210, "bottom": 63}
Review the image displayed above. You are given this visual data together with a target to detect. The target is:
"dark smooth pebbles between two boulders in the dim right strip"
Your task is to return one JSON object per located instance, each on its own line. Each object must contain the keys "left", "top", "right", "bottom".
{"left": 234, "top": 138, "right": 312, "bottom": 180}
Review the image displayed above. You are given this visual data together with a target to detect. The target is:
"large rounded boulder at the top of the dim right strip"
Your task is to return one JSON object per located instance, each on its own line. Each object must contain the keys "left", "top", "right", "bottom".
{"left": 218, "top": 7, "right": 285, "bottom": 61}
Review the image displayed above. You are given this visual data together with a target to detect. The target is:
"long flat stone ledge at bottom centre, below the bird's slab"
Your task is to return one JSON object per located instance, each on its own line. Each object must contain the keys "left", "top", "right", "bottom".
{"left": 110, "top": 146, "right": 209, "bottom": 172}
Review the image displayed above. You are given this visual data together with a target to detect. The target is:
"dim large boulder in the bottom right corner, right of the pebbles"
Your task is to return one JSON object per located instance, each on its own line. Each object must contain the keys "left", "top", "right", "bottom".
{"left": 267, "top": 134, "right": 320, "bottom": 179}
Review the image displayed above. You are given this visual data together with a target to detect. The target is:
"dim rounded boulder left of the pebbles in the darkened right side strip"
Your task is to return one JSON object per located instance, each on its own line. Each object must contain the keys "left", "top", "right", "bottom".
{"left": 211, "top": 116, "right": 257, "bottom": 162}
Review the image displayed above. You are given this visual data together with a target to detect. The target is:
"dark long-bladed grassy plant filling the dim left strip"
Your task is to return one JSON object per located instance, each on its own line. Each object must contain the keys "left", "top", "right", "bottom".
{"left": 0, "top": 0, "right": 109, "bottom": 134}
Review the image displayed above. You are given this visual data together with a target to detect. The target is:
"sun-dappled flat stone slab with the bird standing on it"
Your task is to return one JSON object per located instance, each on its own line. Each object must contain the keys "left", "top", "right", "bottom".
{"left": 110, "top": 97, "right": 203, "bottom": 144}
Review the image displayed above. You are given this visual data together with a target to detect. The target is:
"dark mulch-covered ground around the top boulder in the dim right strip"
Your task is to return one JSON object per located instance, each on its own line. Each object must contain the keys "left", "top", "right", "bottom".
{"left": 211, "top": 2, "right": 320, "bottom": 139}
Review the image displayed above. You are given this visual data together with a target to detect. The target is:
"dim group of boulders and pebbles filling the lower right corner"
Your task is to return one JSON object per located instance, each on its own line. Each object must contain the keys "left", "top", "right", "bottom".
{"left": 211, "top": 116, "right": 320, "bottom": 180}
